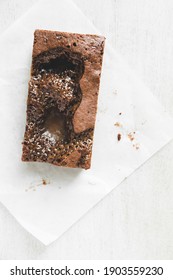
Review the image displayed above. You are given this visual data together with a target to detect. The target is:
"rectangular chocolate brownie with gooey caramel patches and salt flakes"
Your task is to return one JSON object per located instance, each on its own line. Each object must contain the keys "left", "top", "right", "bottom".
{"left": 22, "top": 30, "right": 105, "bottom": 169}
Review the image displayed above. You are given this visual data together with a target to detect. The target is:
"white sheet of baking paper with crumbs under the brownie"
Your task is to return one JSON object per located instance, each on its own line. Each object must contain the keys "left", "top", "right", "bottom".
{"left": 0, "top": 0, "right": 173, "bottom": 245}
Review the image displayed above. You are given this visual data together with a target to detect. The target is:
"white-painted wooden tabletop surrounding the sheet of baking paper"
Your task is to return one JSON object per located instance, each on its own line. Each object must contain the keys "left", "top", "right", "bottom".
{"left": 0, "top": 0, "right": 173, "bottom": 259}
